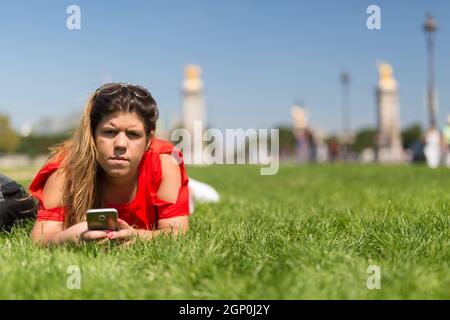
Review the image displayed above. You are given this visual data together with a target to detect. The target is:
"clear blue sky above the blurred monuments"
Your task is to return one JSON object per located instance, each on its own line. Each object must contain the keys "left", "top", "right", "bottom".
{"left": 0, "top": 0, "right": 450, "bottom": 134}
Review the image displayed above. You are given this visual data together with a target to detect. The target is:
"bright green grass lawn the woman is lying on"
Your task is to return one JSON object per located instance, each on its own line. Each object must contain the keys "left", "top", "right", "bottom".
{"left": 0, "top": 165, "right": 450, "bottom": 299}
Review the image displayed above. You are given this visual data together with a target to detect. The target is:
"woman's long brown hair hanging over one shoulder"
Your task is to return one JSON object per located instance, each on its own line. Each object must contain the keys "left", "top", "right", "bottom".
{"left": 49, "top": 83, "right": 159, "bottom": 228}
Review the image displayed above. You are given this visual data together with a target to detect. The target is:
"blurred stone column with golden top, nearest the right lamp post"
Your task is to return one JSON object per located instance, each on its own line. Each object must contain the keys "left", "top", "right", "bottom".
{"left": 376, "top": 63, "right": 404, "bottom": 162}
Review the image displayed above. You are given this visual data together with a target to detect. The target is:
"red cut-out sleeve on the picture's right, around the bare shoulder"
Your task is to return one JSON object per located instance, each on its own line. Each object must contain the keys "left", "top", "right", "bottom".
{"left": 150, "top": 143, "right": 189, "bottom": 219}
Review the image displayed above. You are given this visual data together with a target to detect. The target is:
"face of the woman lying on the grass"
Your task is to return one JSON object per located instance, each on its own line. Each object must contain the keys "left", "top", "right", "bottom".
{"left": 95, "top": 112, "right": 150, "bottom": 178}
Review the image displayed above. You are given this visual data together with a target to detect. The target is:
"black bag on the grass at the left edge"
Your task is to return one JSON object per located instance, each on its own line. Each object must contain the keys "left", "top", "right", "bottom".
{"left": 0, "top": 174, "right": 37, "bottom": 231}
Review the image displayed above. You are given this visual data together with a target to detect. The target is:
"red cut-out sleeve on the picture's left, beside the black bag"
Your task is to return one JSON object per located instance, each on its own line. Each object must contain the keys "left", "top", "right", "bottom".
{"left": 30, "top": 162, "right": 64, "bottom": 221}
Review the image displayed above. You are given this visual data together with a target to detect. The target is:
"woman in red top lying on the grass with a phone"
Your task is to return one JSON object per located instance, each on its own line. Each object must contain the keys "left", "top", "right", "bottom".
{"left": 30, "top": 83, "right": 189, "bottom": 245}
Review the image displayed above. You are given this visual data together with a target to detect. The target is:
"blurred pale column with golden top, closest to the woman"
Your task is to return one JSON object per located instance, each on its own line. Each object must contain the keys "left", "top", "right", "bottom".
{"left": 183, "top": 65, "right": 207, "bottom": 163}
